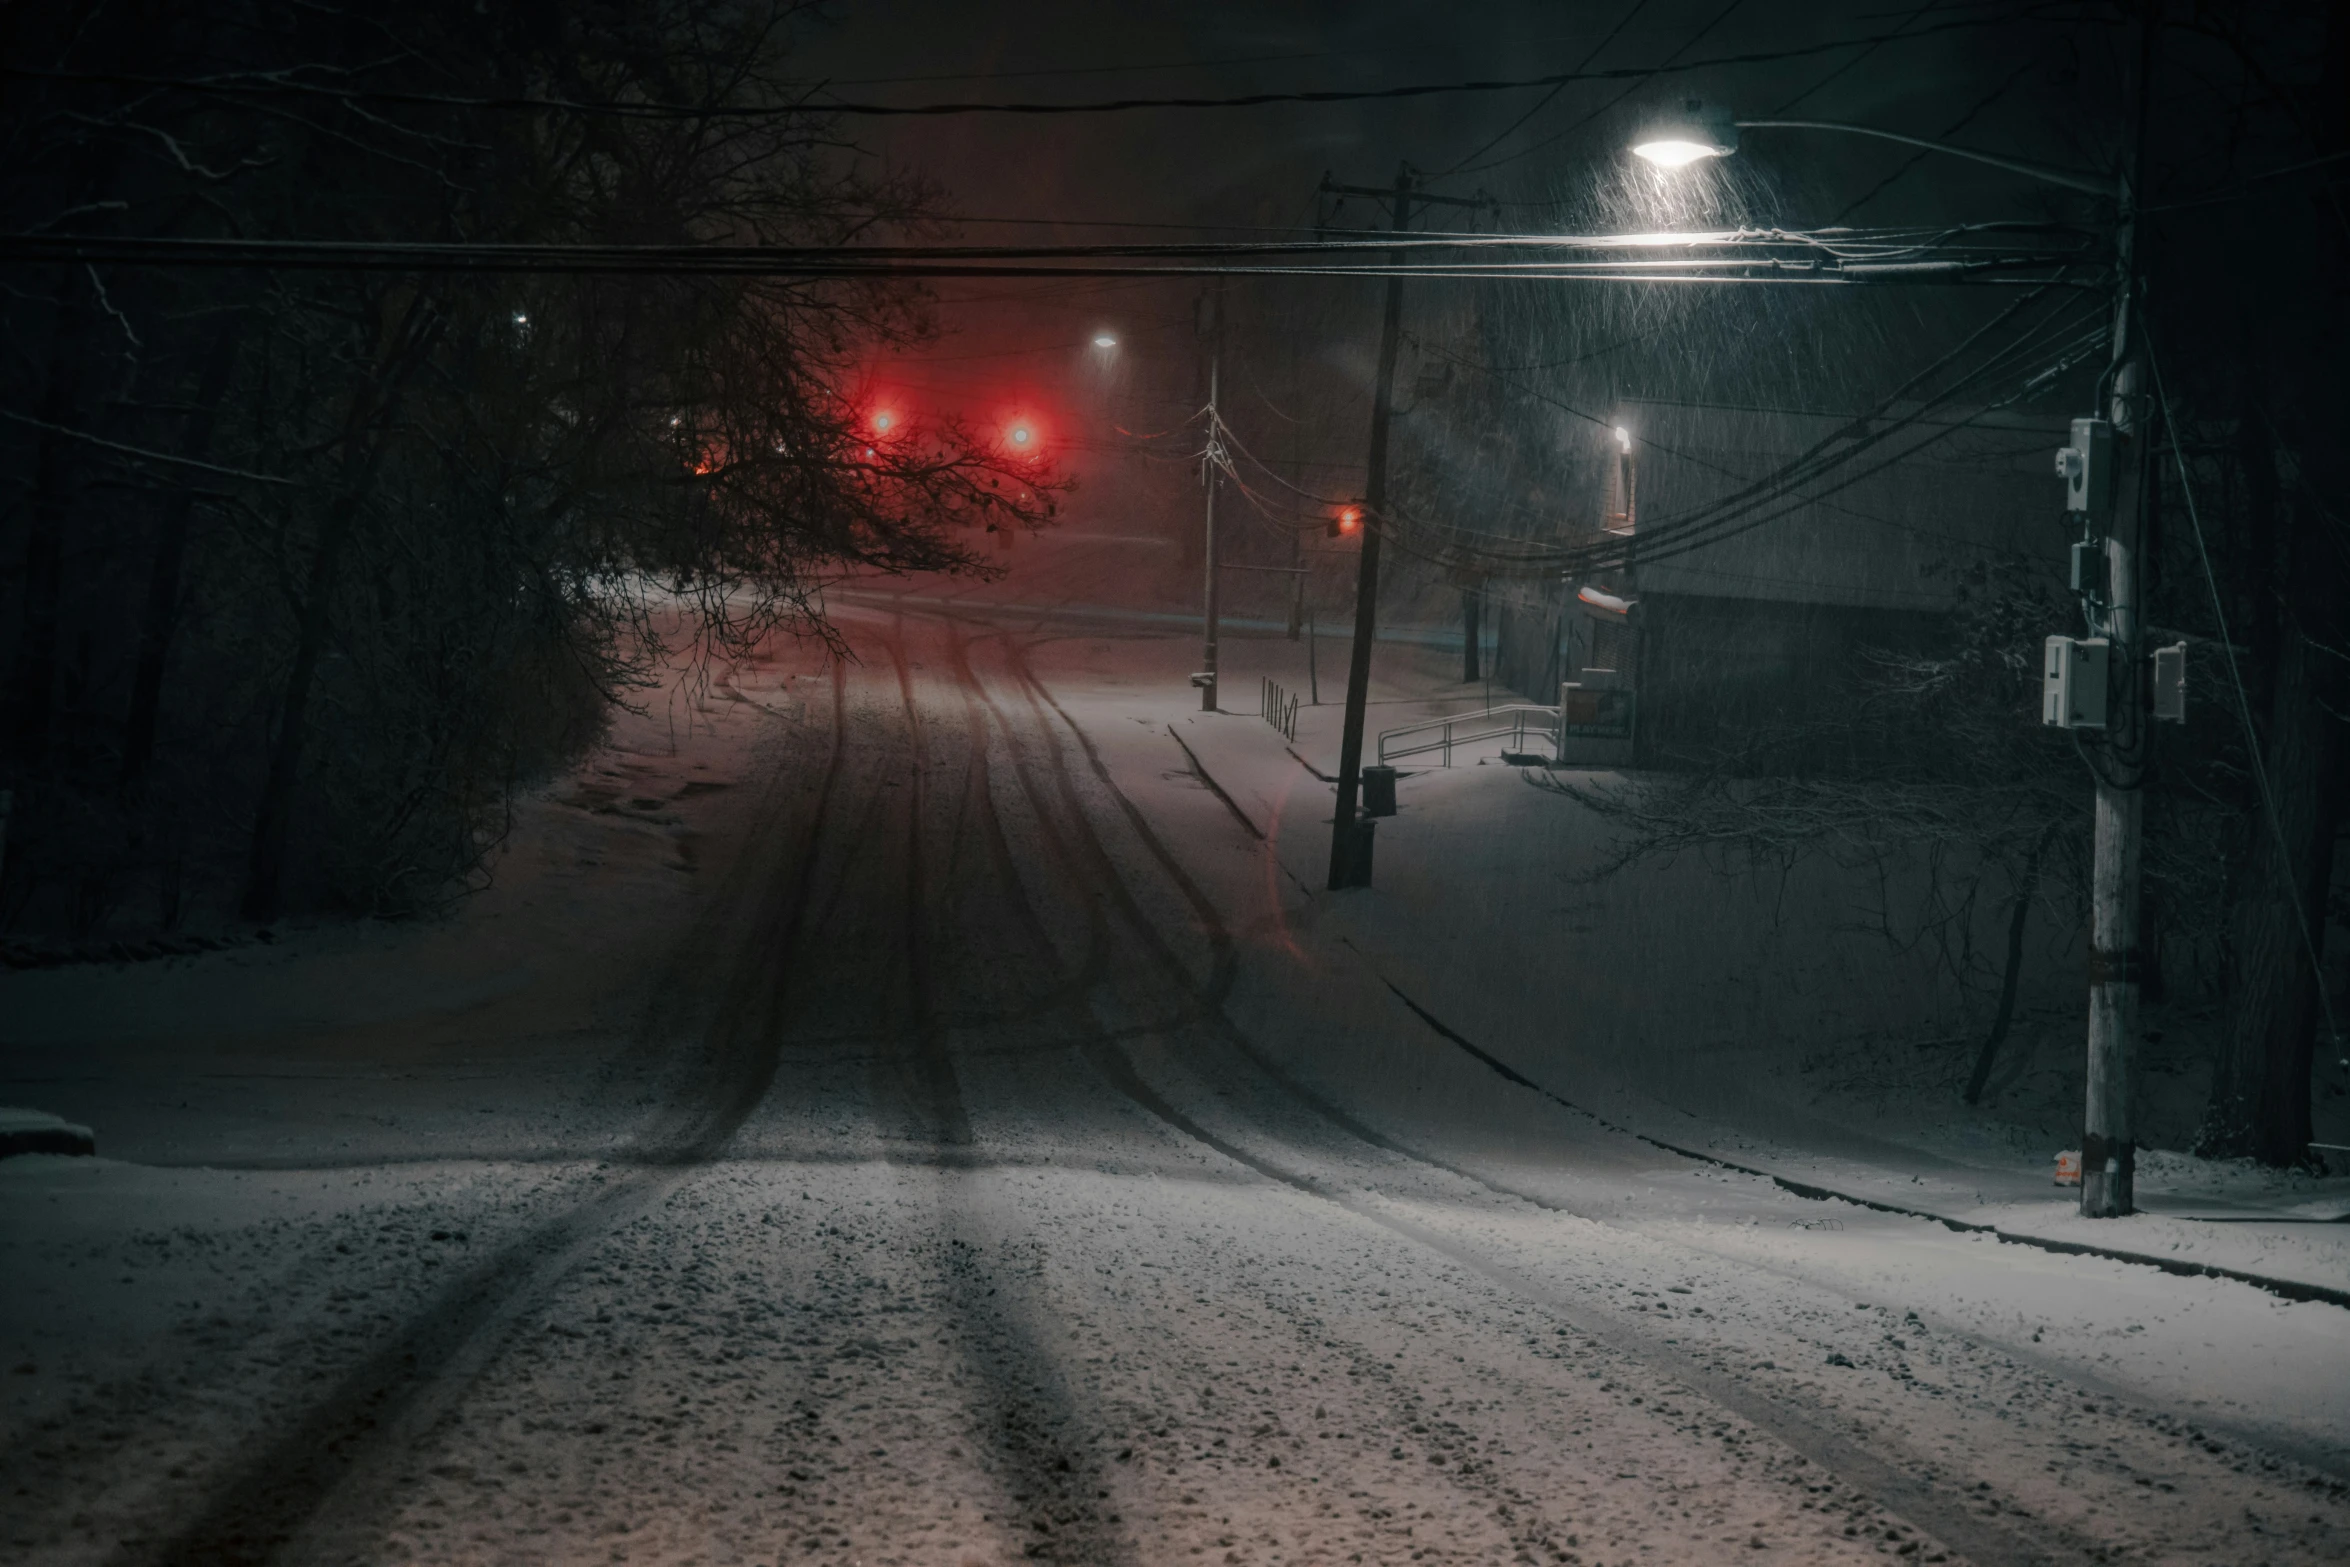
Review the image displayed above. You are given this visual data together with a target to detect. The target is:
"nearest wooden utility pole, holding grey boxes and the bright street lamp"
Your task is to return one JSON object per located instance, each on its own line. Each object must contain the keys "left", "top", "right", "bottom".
{"left": 2080, "top": 3, "right": 2155, "bottom": 1219}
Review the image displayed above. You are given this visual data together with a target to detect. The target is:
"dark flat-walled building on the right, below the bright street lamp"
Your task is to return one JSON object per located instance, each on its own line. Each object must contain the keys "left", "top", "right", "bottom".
{"left": 1488, "top": 397, "right": 2070, "bottom": 766}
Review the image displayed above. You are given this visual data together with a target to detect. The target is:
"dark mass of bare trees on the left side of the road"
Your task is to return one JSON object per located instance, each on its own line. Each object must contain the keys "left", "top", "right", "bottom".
{"left": 0, "top": 0, "right": 1050, "bottom": 944}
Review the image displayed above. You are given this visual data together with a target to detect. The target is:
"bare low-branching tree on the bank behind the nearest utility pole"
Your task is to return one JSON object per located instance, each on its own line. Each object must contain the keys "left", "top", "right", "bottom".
{"left": 1537, "top": 559, "right": 2228, "bottom": 1104}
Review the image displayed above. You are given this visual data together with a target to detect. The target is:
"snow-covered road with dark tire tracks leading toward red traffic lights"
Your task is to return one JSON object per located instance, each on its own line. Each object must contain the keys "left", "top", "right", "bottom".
{"left": 0, "top": 611, "right": 2350, "bottom": 1567}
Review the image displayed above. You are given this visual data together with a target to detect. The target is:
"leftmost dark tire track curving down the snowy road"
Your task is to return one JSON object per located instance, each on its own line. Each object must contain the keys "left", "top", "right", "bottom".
{"left": 108, "top": 663, "right": 846, "bottom": 1567}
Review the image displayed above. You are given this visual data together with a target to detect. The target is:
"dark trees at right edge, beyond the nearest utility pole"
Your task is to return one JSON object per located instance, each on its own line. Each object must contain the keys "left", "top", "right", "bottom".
{"left": 2148, "top": 2, "right": 2350, "bottom": 1165}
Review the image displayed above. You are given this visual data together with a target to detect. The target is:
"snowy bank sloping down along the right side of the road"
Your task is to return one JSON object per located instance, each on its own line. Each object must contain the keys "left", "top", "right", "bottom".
{"left": 1142, "top": 620, "right": 2350, "bottom": 1299}
